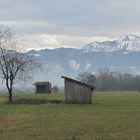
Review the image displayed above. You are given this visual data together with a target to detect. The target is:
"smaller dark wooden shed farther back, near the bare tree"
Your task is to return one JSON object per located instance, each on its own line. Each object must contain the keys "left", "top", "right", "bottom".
{"left": 34, "top": 81, "right": 52, "bottom": 93}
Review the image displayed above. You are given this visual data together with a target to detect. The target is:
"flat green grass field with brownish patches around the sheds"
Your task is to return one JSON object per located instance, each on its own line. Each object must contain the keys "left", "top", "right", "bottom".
{"left": 0, "top": 92, "right": 140, "bottom": 140}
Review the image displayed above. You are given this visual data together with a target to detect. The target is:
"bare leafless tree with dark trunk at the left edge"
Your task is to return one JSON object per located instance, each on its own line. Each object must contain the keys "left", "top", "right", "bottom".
{"left": 0, "top": 26, "right": 37, "bottom": 103}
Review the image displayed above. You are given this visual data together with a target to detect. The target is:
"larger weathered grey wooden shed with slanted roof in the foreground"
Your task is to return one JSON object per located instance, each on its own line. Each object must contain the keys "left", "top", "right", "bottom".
{"left": 62, "top": 76, "right": 95, "bottom": 104}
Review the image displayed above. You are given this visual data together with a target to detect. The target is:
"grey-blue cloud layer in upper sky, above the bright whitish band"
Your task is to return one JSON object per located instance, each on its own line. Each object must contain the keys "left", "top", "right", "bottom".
{"left": 0, "top": 0, "right": 140, "bottom": 37}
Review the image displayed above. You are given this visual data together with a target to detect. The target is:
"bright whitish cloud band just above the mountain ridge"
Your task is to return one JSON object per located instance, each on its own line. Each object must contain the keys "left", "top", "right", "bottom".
{"left": 16, "top": 34, "right": 109, "bottom": 50}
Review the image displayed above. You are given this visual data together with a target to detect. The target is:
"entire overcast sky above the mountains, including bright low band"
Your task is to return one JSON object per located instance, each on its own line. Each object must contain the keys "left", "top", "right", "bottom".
{"left": 0, "top": 0, "right": 140, "bottom": 49}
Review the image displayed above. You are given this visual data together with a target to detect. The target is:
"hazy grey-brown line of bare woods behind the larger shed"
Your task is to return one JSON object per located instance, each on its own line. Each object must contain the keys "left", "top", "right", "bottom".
{"left": 77, "top": 69, "right": 140, "bottom": 91}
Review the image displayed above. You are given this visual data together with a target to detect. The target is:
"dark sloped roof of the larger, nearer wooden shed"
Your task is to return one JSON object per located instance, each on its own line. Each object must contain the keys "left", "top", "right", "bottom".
{"left": 62, "top": 76, "right": 95, "bottom": 90}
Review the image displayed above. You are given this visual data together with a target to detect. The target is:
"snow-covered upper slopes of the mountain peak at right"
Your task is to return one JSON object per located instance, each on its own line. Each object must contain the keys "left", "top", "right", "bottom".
{"left": 83, "top": 34, "right": 140, "bottom": 53}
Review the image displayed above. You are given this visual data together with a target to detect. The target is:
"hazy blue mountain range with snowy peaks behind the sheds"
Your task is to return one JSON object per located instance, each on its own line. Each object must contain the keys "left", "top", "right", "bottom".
{"left": 27, "top": 34, "right": 140, "bottom": 86}
